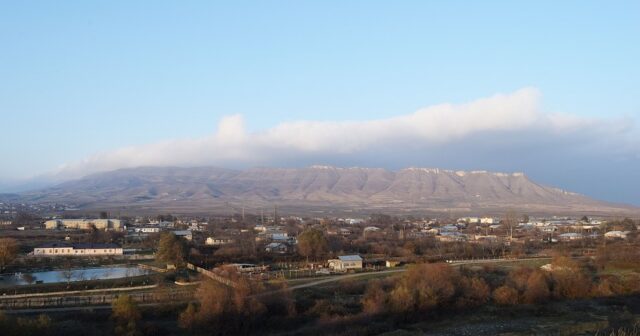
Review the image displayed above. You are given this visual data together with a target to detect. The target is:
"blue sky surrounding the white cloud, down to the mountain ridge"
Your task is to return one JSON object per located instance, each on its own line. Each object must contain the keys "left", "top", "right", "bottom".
{"left": 0, "top": 1, "right": 640, "bottom": 204}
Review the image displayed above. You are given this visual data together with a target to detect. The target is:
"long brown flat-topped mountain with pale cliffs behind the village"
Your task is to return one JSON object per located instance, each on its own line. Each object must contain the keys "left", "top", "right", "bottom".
{"left": 3, "top": 166, "right": 640, "bottom": 216}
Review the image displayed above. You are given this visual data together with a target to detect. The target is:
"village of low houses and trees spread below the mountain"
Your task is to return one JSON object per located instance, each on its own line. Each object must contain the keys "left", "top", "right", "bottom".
{"left": 0, "top": 209, "right": 637, "bottom": 276}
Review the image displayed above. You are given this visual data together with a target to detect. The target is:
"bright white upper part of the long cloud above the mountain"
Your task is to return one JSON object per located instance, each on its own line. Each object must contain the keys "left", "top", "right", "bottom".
{"left": 48, "top": 88, "right": 631, "bottom": 179}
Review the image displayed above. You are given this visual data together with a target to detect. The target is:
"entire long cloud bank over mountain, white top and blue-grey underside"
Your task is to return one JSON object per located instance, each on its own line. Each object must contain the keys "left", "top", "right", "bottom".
{"left": 36, "top": 88, "right": 640, "bottom": 202}
